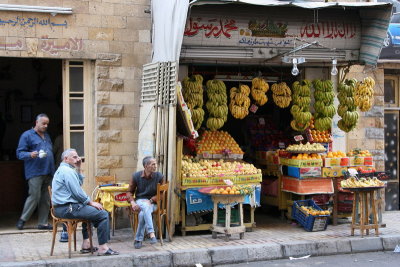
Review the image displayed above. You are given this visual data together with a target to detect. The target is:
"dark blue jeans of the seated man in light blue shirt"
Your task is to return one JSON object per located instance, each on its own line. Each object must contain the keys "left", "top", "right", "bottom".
{"left": 54, "top": 203, "right": 110, "bottom": 245}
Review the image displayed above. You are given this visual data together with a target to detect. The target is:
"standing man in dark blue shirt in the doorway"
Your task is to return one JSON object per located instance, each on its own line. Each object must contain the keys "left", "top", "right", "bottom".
{"left": 16, "top": 114, "right": 54, "bottom": 230}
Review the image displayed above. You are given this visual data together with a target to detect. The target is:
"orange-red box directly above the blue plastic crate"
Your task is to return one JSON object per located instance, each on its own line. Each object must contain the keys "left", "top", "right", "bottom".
{"left": 282, "top": 176, "right": 333, "bottom": 195}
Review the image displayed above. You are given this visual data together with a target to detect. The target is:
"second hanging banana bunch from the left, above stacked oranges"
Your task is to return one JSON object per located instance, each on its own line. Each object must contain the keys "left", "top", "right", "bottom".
{"left": 206, "top": 80, "right": 228, "bottom": 131}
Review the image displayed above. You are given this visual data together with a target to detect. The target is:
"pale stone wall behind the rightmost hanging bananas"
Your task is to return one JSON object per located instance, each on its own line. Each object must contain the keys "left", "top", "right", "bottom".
{"left": 346, "top": 66, "right": 385, "bottom": 171}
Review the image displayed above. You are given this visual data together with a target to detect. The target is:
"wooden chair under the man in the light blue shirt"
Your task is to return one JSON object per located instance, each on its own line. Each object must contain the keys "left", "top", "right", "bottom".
{"left": 48, "top": 186, "right": 93, "bottom": 258}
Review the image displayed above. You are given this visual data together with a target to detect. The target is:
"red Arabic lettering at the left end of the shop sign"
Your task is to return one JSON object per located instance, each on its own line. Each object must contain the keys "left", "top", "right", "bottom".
{"left": 184, "top": 18, "right": 238, "bottom": 38}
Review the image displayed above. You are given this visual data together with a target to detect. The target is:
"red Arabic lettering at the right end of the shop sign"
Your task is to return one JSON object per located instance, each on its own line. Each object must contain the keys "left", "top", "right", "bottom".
{"left": 300, "top": 21, "right": 357, "bottom": 39}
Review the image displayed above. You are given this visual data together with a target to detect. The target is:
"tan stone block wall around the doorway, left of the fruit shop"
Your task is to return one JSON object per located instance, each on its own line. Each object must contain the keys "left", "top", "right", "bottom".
{"left": 0, "top": 0, "right": 151, "bottom": 184}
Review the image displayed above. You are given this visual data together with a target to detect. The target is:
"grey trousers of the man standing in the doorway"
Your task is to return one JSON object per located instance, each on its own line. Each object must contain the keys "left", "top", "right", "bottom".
{"left": 21, "top": 175, "right": 52, "bottom": 225}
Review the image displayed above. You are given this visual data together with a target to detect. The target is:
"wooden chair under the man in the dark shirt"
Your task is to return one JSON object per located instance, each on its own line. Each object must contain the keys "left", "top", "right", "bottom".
{"left": 129, "top": 183, "right": 172, "bottom": 245}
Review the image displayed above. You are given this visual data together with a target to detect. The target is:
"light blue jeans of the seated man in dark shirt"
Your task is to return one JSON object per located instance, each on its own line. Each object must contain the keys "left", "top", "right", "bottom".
{"left": 135, "top": 199, "right": 157, "bottom": 241}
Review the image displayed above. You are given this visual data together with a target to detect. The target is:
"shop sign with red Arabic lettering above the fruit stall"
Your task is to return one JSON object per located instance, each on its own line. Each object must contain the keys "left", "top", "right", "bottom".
{"left": 183, "top": 6, "right": 361, "bottom": 49}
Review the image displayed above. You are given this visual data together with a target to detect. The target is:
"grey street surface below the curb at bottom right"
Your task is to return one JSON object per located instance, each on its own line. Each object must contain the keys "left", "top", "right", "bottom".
{"left": 216, "top": 251, "right": 400, "bottom": 267}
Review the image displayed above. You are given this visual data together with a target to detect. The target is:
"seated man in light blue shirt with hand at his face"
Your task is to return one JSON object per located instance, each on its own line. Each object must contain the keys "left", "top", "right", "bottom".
{"left": 52, "top": 148, "right": 119, "bottom": 256}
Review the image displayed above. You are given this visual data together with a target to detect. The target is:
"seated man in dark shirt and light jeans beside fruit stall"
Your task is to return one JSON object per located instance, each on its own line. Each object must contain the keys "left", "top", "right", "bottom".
{"left": 128, "top": 156, "right": 164, "bottom": 249}
